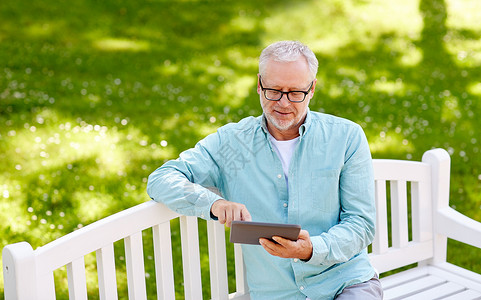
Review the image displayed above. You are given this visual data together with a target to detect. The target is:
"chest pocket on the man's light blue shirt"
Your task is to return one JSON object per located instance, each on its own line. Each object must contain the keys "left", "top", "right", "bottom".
{"left": 309, "top": 169, "right": 341, "bottom": 213}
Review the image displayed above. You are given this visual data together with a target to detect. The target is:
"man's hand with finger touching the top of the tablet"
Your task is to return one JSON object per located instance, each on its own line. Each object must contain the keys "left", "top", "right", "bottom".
{"left": 210, "top": 199, "right": 252, "bottom": 227}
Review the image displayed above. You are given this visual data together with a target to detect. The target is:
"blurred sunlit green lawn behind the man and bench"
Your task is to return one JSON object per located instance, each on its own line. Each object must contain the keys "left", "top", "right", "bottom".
{"left": 0, "top": 0, "right": 481, "bottom": 299}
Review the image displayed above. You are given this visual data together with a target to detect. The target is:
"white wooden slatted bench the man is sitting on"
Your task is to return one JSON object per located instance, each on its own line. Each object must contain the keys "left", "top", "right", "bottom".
{"left": 3, "top": 149, "right": 481, "bottom": 300}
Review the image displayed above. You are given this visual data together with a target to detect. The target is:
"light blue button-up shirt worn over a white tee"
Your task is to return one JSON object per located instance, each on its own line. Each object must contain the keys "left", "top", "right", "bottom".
{"left": 147, "top": 111, "right": 375, "bottom": 300}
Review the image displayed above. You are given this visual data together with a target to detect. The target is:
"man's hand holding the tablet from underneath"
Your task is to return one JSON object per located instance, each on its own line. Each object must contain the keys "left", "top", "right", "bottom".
{"left": 259, "top": 230, "right": 312, "bottom": 260}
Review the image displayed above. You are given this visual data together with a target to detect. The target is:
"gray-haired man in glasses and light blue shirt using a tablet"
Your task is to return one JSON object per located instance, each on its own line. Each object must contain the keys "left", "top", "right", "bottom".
{"left": 147, "top": 41, "right": 382, "bottom": 300}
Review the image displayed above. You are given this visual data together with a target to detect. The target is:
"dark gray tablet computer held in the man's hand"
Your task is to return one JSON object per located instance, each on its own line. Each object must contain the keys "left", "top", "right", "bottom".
{"left": 230, "top": 221, "right": 301, "bottom": 245}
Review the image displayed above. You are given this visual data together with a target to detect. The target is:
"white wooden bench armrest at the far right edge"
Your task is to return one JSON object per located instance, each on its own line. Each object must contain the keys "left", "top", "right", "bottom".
{"left": 434, "top": 207, "right": 481, "bottom": 249}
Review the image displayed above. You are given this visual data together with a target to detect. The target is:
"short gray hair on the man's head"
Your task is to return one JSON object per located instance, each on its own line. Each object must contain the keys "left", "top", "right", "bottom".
{"left": 259, "top": 41, "right": 319, "bottom": 80}
